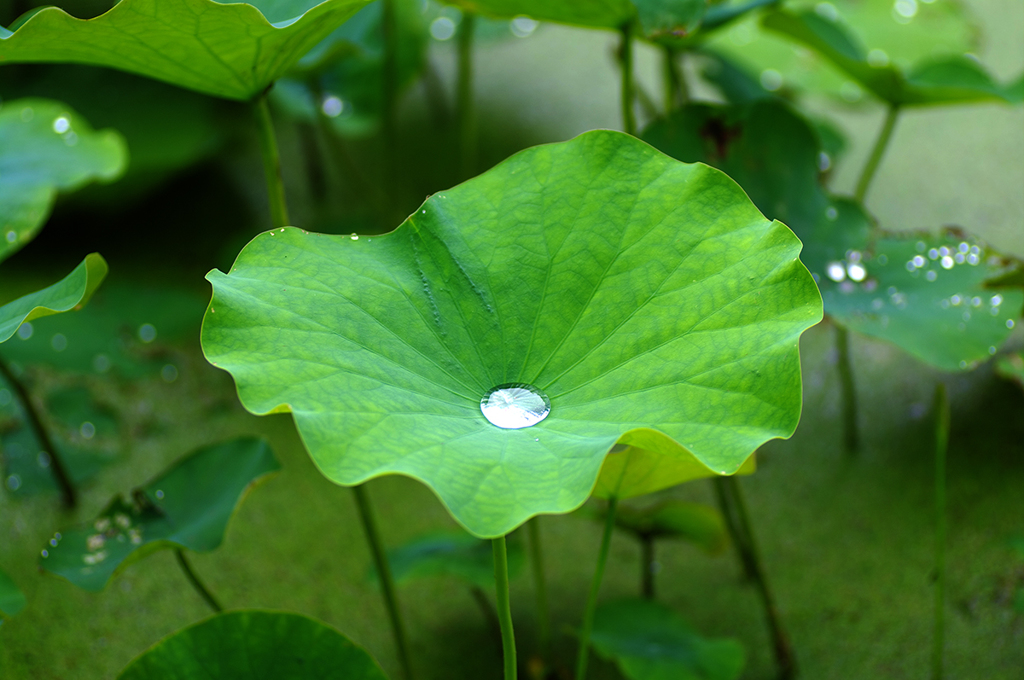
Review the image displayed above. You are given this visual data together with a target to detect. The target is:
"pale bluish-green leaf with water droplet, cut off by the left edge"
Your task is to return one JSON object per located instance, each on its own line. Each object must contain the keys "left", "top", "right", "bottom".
{"left": 0, "top": 98, "right": 128, "bottom": 261}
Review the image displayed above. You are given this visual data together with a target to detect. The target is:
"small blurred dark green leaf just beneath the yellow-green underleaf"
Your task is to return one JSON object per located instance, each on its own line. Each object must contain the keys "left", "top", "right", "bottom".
{"left": 615, "top": 499, "right": 729, "bottom": 554}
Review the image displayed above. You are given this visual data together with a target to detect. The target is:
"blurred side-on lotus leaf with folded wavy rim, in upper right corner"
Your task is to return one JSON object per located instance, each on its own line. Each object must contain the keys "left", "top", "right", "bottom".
{"left": 763, "top": 11, "right": 1019, "bottom": 105}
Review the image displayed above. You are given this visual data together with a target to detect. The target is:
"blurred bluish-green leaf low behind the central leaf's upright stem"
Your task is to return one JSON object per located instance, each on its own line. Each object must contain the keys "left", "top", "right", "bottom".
{"left": 371, "top": 532, "right": 525, "bottom": 591}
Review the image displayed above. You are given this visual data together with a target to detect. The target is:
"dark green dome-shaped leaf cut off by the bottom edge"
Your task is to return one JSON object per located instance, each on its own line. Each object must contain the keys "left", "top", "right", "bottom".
{"left": 118, "top": 609, "right": 387, "bottom": 680}
